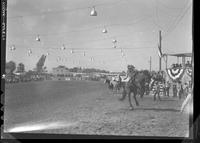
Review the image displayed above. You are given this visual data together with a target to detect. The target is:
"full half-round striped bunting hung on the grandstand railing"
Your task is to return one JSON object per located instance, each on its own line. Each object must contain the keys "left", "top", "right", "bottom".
{"left": 167, "top": 68, "right": 184, "bottom": 81}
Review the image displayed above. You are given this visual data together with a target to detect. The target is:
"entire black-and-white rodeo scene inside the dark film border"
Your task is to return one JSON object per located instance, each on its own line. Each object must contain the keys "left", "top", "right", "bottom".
{"left": 2, "top": 0, "right": 194, "bottom": 138}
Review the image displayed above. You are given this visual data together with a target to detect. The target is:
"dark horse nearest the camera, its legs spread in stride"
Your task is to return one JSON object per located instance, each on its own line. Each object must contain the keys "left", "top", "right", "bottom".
{"left": 120, "top": 71, "right": 150, "bottom": 110}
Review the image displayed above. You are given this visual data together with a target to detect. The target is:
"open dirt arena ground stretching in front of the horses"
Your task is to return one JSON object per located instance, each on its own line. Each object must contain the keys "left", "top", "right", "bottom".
{"left": 4, "top": 81, "right": 189, "bottom": 137}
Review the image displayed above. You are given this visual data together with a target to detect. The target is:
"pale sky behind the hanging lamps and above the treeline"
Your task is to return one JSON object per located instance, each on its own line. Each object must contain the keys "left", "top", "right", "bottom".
{"left": 6, "top": 0, "right": 192, "bottom": 72}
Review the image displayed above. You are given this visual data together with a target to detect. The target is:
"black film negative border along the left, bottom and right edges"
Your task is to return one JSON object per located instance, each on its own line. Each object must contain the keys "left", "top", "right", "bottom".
{"left": 1, "top": 0, "right": 200, "bottom": 142}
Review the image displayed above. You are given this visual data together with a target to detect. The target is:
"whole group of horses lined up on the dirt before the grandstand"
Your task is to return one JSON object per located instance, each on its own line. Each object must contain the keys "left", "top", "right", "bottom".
{"left": 104, "top": 70, "right": 165, "bottom": 110}
